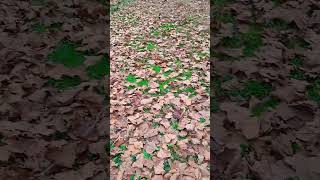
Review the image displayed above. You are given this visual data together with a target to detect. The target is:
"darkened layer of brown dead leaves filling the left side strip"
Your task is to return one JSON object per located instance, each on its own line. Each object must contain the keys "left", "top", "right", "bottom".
{"left": 0, "top": 0, "right": 108, "bottom": 180}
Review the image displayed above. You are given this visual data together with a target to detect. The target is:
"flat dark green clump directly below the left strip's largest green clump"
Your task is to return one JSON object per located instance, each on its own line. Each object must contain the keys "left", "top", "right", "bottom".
{"left": 48, "top": 75, "right": 81, "bottom": 90}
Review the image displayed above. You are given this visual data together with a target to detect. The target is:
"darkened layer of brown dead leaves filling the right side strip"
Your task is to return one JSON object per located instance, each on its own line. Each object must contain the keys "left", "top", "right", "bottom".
{"left": 211, "top": 0, "right": 320, "bottom": 180}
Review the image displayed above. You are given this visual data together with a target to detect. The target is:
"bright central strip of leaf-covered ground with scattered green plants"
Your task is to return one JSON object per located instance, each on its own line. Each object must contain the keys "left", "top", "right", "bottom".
{"left": 110, "top": 0, "right": 210, "bottom": 180}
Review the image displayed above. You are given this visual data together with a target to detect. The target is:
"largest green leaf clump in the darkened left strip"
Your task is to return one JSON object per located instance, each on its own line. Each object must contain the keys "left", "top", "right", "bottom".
{"left": 48, "top": 41, "right": 85, "bottom": 68}
